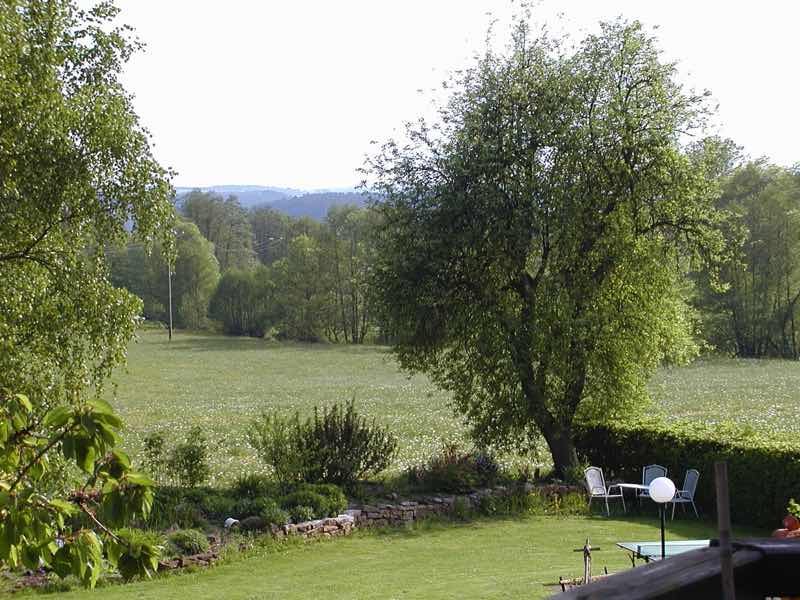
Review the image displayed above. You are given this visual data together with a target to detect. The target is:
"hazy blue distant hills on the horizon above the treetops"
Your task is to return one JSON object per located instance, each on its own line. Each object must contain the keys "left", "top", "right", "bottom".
{"left": 175, "top": 185, "right": 364, "bottom": 221}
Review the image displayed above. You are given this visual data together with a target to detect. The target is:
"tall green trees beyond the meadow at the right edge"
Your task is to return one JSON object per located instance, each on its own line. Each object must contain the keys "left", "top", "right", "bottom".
{"left": 697, "top": 157, "right": 800, "bottom": 359}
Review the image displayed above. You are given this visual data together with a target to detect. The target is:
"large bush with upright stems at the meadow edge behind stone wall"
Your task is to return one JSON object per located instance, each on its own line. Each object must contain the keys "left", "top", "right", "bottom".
{"left": 248, "top": 401, "right": 397, "bottom": 485}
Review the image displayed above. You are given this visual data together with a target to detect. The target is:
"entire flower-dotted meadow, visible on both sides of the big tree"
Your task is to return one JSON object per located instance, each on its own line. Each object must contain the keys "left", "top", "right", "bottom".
{"left": 108, "top": 330, "right": 800, "bottom": 483}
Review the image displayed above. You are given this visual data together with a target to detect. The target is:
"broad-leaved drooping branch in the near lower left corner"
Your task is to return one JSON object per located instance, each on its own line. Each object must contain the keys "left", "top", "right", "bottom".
{"left": 0, "top": 392, "right": 158, "bottom": 587}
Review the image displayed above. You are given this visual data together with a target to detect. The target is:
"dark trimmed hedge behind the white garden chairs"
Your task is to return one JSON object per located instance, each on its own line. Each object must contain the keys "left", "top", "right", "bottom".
{"left": 576, "top": 421, "right": 800, "bottom": 529}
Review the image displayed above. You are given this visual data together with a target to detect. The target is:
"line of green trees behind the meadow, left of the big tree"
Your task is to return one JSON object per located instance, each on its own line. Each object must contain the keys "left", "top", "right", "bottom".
{"left": 109, "top": 191, "right": 379, "bottom": 344}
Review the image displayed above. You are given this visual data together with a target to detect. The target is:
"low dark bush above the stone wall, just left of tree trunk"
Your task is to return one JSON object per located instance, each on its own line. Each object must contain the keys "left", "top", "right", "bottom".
{"left": 409, "top": 444, "right": 499, "bottom": 494}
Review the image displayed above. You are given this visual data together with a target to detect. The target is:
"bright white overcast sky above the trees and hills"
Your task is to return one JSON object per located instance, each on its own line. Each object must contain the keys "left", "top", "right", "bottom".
{"left": 111, "top": 0, "right": 800, "bottom": 189}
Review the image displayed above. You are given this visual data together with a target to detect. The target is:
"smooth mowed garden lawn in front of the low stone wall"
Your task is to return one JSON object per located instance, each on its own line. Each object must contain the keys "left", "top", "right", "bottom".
{"left": 50, "top": 511, "right": 764, "bottom": 600}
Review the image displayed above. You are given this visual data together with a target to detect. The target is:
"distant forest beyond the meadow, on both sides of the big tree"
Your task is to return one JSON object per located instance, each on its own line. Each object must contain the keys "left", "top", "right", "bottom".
{"left": 110, "top": 155, "right": 800, "bottom": 359}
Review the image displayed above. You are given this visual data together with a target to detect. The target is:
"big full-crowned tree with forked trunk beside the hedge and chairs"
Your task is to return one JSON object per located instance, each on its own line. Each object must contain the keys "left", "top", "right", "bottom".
{"left": 366, "top": 19, "right": 716, "bottom": 473}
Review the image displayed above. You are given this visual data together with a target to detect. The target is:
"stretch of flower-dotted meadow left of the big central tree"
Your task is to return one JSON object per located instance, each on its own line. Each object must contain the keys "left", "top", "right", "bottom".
{"left": 109, "top": 330, "right": 464, "bottom": 483}
